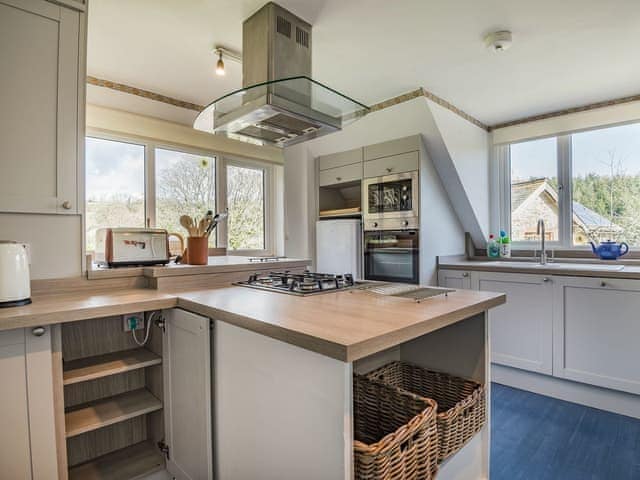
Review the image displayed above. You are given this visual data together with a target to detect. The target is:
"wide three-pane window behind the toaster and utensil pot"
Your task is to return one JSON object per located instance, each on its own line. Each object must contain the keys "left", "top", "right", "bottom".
{"left": 85, "top": 134, "right": 272, "bottom": 255}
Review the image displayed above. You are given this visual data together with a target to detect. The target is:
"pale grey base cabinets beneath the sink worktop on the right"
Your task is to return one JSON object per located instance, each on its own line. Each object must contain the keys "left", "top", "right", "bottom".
{"left": 438, "top": 269, "right": 640, "bottom": 395}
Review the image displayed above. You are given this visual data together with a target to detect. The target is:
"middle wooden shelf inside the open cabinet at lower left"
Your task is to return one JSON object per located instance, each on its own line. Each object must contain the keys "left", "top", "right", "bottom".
{"left": 64, "top": 388, "right": 162, "bottom": 438}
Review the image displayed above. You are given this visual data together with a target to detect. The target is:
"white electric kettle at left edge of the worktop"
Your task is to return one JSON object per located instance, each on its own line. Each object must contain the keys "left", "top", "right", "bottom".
{"left": 0, "top": 240, "right": 31, "bottom": 308}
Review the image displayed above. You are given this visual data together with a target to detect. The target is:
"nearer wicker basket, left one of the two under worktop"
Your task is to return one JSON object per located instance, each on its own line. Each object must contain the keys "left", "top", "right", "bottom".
{"left": 353, "top": 375, "right": 438, "bottom": 480}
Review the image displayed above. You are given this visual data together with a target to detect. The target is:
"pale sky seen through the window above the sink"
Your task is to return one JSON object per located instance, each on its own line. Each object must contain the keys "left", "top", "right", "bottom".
{"left": 511, "top": 123, "right": 640, "bottom": 180}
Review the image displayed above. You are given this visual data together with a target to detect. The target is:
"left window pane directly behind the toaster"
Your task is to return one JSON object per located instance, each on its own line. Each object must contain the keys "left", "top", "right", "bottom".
{"left": 85, "top": 137, "right": 145, "bottom": 251}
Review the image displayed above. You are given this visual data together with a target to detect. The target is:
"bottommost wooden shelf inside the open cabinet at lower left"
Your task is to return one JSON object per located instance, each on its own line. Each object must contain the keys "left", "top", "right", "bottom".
{"left": 69, "top": 442, "right": 164, "bottom": 480}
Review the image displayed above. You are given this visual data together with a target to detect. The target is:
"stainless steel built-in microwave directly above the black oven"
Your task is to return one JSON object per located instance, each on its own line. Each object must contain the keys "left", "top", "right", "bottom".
{"left": 362, "top": 171, "right": 420, "bottom": 230}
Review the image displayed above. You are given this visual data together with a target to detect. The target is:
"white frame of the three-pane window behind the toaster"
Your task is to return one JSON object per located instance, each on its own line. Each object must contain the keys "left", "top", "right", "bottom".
{"left": 82, "top": 128, "right": 277, "bottom": 256}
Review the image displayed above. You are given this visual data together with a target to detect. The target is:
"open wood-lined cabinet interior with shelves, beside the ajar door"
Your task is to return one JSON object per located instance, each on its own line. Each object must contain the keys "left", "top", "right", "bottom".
{"left": 61, "top": 317, "right": 166, "bottom": 480}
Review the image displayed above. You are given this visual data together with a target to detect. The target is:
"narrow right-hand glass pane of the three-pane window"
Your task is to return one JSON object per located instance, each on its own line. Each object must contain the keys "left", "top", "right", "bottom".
{"left": 227, "top": 165, "right": 265, "bottom": 250}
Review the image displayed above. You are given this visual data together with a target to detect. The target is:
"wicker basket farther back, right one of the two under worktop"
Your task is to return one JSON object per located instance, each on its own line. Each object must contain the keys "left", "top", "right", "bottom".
{"left": 367, "top": 362, "right": 486, "bottom": 462}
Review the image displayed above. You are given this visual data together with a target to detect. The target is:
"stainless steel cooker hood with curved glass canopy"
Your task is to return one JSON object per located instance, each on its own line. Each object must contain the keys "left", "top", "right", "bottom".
{"left": 193, "top": 2, "right": 369, "bottom": 147}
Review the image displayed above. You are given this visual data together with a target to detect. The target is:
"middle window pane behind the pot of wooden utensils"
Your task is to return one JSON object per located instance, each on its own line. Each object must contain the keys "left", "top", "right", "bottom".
{"left": 155, "top": 148, "right": 216, "bottom": 246}
